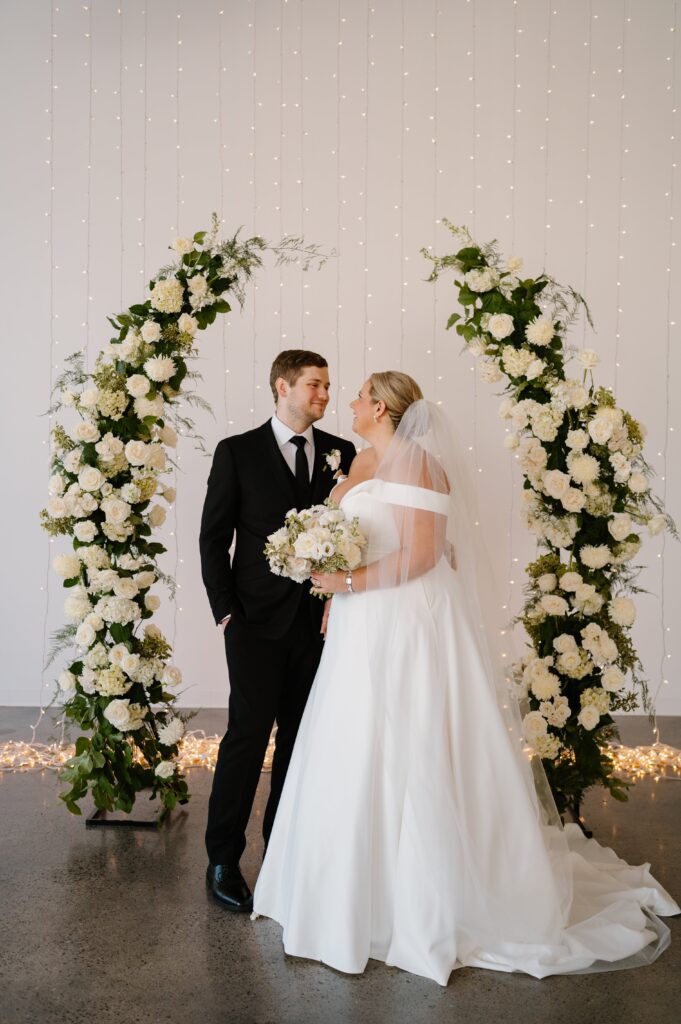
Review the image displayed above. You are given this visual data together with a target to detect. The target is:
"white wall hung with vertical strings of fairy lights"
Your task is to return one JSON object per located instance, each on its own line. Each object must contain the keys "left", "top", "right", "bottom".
{"left": 0, "top": 0, "right": 681, "bottom": 714}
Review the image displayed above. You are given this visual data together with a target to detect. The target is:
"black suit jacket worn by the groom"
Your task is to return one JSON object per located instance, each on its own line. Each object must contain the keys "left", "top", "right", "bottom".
{"left": 200, "top": 420, "right": 355, "bottom": 638}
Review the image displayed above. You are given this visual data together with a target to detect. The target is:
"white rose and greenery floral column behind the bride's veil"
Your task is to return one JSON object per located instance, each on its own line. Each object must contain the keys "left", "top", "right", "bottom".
{"left": 422, "top": 221, "right": 678, "bottom": 813}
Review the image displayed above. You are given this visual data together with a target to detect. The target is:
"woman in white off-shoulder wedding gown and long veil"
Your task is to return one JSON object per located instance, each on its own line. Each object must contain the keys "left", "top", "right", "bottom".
{"left": 254, "top": 372, "right": 679, "bottom": 985}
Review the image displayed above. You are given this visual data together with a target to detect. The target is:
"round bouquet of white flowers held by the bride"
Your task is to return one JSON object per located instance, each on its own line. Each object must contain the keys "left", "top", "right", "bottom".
{"left": 264, "top": 499, "right": 367, "bottom": 596}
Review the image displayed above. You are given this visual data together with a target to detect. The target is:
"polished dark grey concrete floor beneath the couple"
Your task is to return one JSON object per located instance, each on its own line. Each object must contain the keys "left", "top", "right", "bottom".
{"left": 0, "top": 709, "right": 681, "bottom": 1024}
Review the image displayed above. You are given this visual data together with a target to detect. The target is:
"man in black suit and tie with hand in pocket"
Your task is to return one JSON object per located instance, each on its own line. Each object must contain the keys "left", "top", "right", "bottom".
{"left": 200, "top": 349, "right": 355, "bottom": 910}
